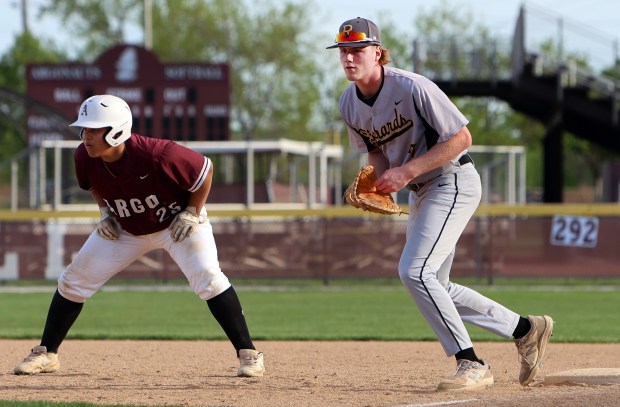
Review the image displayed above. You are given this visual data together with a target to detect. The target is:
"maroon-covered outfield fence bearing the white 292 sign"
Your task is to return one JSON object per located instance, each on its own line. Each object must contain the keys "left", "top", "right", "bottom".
{"left": 0, "top": 210, "right": 620, "bottom": 282}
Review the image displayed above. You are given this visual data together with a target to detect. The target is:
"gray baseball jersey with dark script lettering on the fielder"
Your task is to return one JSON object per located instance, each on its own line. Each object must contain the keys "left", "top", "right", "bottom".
{"left": 340, "top": 66, "right": 468, "bottom": 183}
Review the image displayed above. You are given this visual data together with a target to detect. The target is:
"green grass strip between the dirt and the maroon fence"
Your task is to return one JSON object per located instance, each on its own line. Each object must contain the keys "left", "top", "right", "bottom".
{"left": 0, "top": 280, "right": 620, "bottom": 343}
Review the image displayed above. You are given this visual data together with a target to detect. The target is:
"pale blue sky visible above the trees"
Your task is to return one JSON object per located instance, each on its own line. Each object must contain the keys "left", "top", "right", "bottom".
{"left": 0, "top": 0, "right": 620, "bottom": 69}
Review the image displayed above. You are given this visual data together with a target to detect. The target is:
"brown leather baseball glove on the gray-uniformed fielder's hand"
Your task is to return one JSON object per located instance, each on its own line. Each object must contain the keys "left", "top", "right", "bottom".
{"left": 344, "top": 165, "right": 405, "bottom": 215}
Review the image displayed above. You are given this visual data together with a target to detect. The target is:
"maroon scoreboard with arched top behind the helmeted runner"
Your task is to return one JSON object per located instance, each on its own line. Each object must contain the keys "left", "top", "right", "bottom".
{"left": 26, "top": 44, "right": 230, "bottom": 146}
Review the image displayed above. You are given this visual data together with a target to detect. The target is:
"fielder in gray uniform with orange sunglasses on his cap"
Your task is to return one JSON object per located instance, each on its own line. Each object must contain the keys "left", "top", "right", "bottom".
{"left": 327, "top": 17, "right": 553, "bottom": 390}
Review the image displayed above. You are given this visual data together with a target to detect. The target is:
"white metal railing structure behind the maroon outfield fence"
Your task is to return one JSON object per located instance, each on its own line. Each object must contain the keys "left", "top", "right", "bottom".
{"left": 5, "top": 139, "right": 527, "bottom": 211}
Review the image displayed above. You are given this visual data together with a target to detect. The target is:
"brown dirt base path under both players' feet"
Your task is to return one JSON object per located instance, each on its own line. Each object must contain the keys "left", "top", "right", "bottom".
{"left": 0, "top": 340, "right": 620, "bottom": 407}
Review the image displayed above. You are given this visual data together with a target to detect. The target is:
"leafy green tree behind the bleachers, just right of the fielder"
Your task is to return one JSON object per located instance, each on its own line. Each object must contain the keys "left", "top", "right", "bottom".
{"left": 415, "top": 0, "right": 545, "bottom": 194}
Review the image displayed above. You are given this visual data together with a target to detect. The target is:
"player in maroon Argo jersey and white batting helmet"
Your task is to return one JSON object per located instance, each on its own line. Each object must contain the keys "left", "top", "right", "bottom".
{"left": 14, "top": 95, "right": 264, "bottom": 377}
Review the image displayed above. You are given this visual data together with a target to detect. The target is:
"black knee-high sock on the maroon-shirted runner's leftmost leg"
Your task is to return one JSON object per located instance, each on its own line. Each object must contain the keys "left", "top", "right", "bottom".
{"left": 41, "top": 290, "right": 84, "bottom": 353}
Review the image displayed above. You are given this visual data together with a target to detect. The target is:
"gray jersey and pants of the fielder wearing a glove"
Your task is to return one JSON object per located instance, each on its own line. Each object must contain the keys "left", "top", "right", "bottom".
{"left": 340, "top": 66, "right": 519, "bottom": 356}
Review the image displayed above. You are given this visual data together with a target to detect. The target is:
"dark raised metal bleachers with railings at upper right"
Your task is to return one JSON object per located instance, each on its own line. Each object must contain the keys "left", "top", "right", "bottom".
{"left": 413, "top": 5, "right": 620, "bottom": 202}
